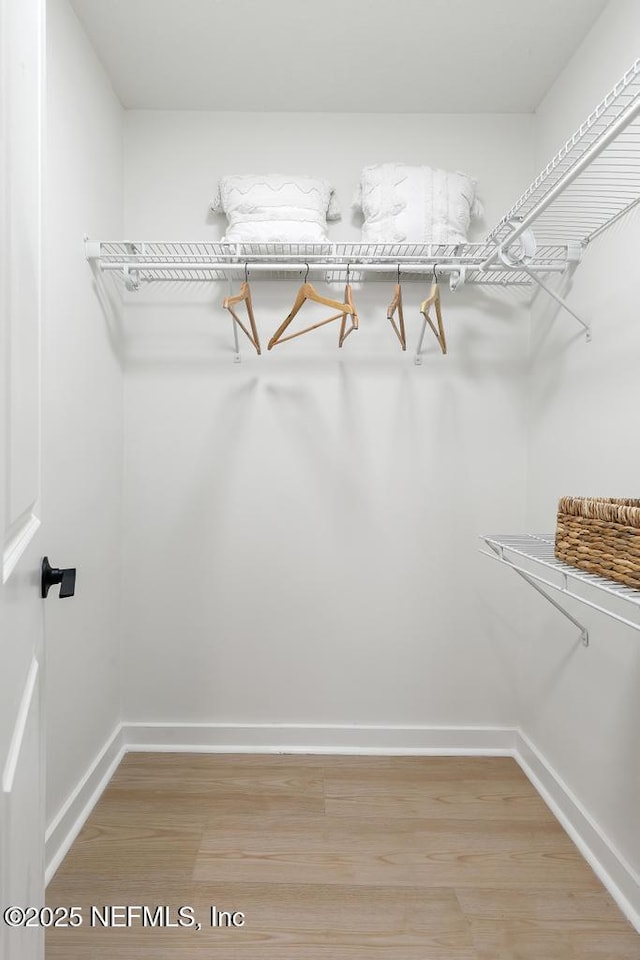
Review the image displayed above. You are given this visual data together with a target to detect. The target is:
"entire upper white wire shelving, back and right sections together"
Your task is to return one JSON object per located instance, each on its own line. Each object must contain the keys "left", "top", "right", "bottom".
{"left": 86, "top": 59, "right": 640, "bottom": 339}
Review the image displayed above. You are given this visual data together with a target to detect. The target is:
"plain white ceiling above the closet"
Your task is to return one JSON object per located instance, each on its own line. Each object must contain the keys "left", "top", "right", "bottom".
{"left": 71, "top": 0, "right": 607, "bottom": 113}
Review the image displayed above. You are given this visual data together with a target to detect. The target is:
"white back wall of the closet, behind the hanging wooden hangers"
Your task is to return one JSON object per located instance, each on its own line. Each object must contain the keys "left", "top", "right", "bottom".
{"left": 124, "top": 112, "right": 533, "bottom": 726}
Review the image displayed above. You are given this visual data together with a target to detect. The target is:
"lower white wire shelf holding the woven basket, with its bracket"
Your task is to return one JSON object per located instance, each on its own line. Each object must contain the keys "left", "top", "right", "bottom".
{"left": 480, "top": 534, "right": 640, "bottom": 646}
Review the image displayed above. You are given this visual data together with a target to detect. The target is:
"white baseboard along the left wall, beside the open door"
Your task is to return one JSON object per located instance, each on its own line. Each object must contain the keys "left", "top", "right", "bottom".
{"left": 45, "top": 723, "right": 127, "bottom": 883}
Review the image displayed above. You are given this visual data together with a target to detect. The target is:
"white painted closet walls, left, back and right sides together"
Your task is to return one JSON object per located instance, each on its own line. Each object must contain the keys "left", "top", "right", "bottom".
{"left": 44, "top": 0, "right": 640, "bottom": 928}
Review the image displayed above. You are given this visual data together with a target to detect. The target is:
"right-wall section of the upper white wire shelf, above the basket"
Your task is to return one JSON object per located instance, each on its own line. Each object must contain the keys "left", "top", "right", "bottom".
{"left": 487, "top": 59, "right": 640, "bottom": 246}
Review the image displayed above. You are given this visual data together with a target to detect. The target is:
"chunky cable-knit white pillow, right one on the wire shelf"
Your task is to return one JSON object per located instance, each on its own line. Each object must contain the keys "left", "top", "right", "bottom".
{"left": 354, "top": 163, "right": 482, "bottom": 243}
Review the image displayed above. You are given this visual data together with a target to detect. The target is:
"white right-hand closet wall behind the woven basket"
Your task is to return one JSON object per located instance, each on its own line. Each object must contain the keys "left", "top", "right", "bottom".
{"left": 522, "top": 0, "right": 640, "bottom": 914}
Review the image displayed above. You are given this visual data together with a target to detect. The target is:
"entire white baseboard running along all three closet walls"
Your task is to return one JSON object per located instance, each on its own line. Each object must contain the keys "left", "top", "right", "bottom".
{"left": 46, "top": 723, "right": 640, "bottom": 932}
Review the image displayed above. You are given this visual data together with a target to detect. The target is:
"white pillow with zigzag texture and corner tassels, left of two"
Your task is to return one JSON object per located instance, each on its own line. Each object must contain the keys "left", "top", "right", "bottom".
{"left": 211, "top": 174, "right": 340, "bottom": 243}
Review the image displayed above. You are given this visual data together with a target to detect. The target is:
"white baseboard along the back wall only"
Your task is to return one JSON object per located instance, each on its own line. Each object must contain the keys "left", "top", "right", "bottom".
{"left": 124, "top": 723, "right": 515, "bottom": 757}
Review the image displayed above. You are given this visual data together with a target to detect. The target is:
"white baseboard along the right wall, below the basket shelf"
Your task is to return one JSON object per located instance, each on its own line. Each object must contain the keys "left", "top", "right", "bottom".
{"left": 514, "top": 732, "right": 640, "bottom": 932}
